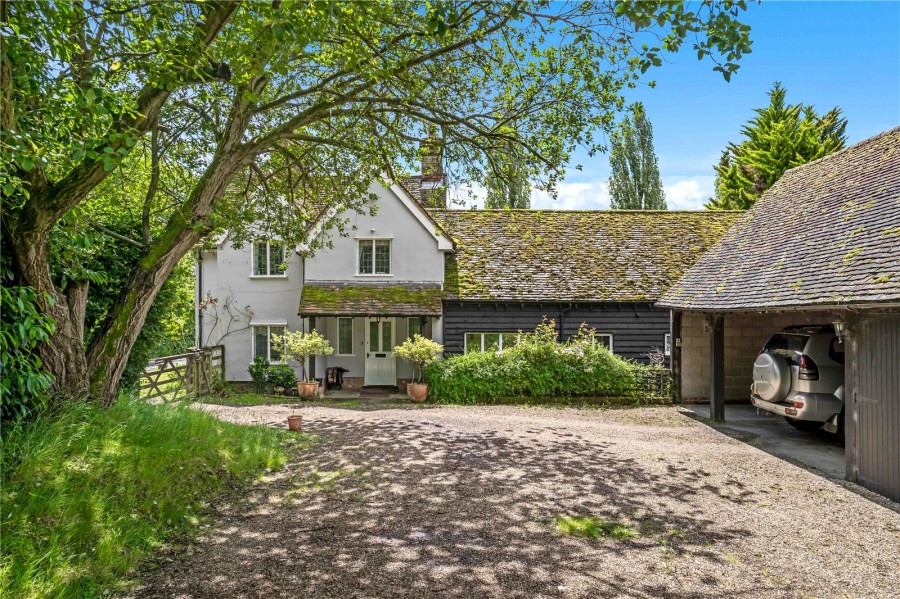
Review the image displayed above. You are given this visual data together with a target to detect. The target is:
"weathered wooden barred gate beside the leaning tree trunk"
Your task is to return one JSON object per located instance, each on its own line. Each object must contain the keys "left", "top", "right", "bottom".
{"left": 138, "top": 345, "right": 225, "bottom": 401}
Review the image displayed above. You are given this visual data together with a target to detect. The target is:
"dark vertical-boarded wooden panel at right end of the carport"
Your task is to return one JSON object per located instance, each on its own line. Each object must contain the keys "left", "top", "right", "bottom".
{"left": 851, "top": 315, "right": 900, "bottom": 501}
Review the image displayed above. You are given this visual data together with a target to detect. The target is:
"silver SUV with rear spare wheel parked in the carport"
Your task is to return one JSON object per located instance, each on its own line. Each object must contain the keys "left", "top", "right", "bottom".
{"left": 750, "top": 325, "right": 844, "bottom": 440}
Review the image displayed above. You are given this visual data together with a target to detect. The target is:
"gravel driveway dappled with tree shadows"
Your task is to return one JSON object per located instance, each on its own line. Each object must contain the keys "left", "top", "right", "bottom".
{"left": 133, "top": 406, "right": 900, "bottom": 598}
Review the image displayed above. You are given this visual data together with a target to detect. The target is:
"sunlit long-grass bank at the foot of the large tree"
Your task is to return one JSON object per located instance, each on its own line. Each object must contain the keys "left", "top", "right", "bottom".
{"left": 0, "top": 400, "right": 297, "bottom": 597}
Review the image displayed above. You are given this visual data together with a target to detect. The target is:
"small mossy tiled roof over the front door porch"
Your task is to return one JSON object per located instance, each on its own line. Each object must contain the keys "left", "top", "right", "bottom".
{"left": 298, "top": 281, "right": 442, "bottom": 316}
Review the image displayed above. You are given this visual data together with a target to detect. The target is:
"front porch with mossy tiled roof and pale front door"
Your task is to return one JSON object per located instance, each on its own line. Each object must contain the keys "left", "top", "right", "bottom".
{"left": 299, "top": 281, "right": 442, "bottom": 394}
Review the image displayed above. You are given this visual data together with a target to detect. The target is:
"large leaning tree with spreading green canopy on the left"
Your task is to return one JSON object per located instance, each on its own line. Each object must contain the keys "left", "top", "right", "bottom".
{"left": 0, "top": 0, "right": 750, "bottom": 403}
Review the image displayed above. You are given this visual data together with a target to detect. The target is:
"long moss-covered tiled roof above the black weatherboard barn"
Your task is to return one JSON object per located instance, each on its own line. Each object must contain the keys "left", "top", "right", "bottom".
{"left": 432, "top": 210, "right": 743, "bottom": 302}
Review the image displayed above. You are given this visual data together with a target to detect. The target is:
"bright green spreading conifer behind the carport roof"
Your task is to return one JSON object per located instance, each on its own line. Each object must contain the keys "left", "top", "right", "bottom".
{"left": 706, "top": 82, "right": 847, "bottom": 210}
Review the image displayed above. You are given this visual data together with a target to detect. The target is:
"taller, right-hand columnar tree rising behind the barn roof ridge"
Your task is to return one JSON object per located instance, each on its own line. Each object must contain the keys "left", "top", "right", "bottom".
{"left": 609, "top": 103, "right": 666, "bottom": 210}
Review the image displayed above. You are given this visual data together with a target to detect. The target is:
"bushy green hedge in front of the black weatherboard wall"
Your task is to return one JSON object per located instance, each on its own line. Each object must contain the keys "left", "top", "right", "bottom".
{"left": 426, "top": 321, "right": 665, "bottom": 404}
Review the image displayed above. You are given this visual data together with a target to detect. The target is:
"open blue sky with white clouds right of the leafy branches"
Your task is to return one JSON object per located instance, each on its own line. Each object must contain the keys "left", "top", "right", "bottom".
{"left": 532, "top": 1, "right": 900, "bottom": 209}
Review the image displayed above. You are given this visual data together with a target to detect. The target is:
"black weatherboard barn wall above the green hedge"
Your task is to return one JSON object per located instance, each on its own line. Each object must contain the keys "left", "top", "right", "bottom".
{"left": 444, "top": 301, "right": 669, "bottom": 362}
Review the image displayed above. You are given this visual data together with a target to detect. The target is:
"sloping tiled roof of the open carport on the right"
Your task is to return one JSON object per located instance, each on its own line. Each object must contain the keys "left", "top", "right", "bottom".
{"left": 659, "top": 127, "right": 900, "bottom": 310}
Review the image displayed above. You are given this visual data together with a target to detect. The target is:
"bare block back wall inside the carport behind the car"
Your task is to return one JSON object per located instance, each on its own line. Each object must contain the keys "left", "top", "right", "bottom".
{"left": 681, "top": 312, "right": 837, "bottom": 402}
